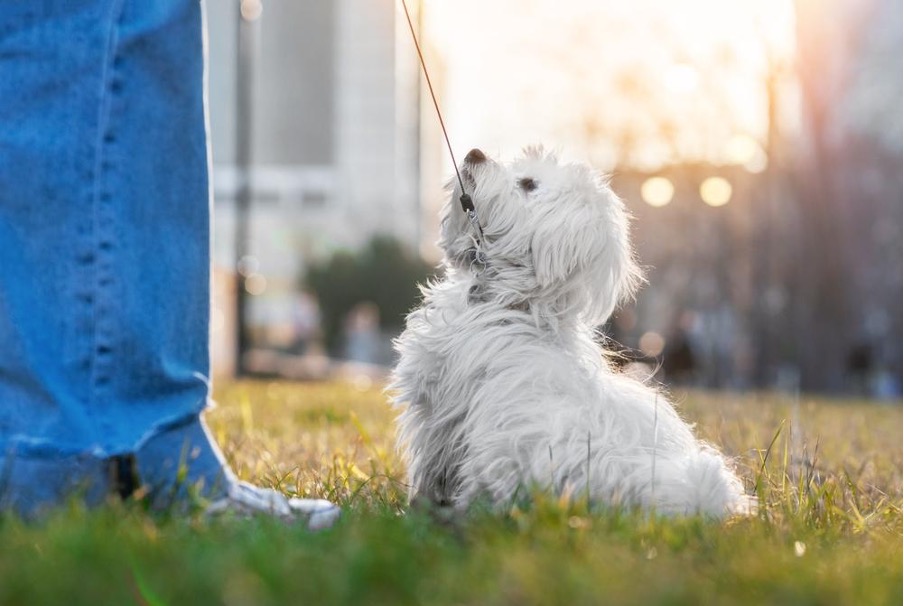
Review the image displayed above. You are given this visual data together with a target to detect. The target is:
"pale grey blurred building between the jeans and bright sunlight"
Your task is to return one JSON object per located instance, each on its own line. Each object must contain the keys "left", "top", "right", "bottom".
{"left": 206, "top": 0, "right": 421, "bottom": 370}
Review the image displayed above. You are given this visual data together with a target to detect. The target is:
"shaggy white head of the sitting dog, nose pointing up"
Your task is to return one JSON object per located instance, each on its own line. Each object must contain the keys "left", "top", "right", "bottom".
{"left": 439, "top": 148, "right": 641, "bottom": 323}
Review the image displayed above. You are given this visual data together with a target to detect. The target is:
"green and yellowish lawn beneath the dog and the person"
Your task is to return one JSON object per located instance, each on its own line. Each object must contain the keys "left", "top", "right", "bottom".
{"left": 0, "top": 383, "right": 902, "bottom": 605}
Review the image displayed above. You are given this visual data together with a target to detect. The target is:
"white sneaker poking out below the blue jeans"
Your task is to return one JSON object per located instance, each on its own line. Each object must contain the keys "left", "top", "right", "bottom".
{"left": 207, "top": 481, "right": 342, "bottom": 530}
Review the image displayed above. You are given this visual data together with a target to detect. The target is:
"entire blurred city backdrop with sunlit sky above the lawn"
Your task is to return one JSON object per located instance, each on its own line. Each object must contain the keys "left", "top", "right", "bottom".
{"left": 207, "top": 0, "right": 904, "bottom": 401}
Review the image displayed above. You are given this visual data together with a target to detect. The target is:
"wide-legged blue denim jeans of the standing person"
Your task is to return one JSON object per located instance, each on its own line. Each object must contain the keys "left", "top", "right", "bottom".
{"left": 0, "top": 0, "right": 228, "bottom": 515}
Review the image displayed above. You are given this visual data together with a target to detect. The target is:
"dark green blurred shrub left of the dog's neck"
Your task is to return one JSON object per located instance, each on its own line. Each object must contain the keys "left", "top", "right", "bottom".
{"left": 303, "top": 236, "right": 435, "bottom": 354}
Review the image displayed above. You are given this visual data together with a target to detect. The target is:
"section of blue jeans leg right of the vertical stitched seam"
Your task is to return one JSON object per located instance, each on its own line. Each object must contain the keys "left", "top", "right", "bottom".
{"left": 82, "top": 0, "right": 227, "bottom": 502}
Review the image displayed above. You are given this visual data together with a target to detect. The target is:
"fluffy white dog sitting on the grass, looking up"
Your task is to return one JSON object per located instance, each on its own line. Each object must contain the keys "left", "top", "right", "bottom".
{"left": 390, "top": 149, "right": 751, "bottom": 516}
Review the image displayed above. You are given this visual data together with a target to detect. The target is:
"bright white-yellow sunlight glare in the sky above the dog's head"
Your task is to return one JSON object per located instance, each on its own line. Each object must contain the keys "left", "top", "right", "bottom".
{"left": 421, "top": 0, "right": 794, "bottom": 172}
